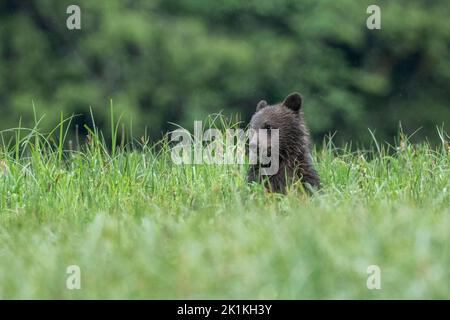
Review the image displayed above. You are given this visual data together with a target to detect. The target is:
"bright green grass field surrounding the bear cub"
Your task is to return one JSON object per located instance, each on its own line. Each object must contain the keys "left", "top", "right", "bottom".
{"left": 0, "top": 115, "right": 450, "bottom": 299}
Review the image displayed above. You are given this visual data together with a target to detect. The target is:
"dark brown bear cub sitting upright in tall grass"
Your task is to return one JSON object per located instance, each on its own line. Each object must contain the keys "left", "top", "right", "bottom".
{"left": 247, "top": 93, "right": 320, "bottom": 193}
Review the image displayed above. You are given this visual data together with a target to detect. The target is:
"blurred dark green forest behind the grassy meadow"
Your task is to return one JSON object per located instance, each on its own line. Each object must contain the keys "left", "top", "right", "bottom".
{"left": 0, "top": 0, "right": 450, "bottom": 143}
